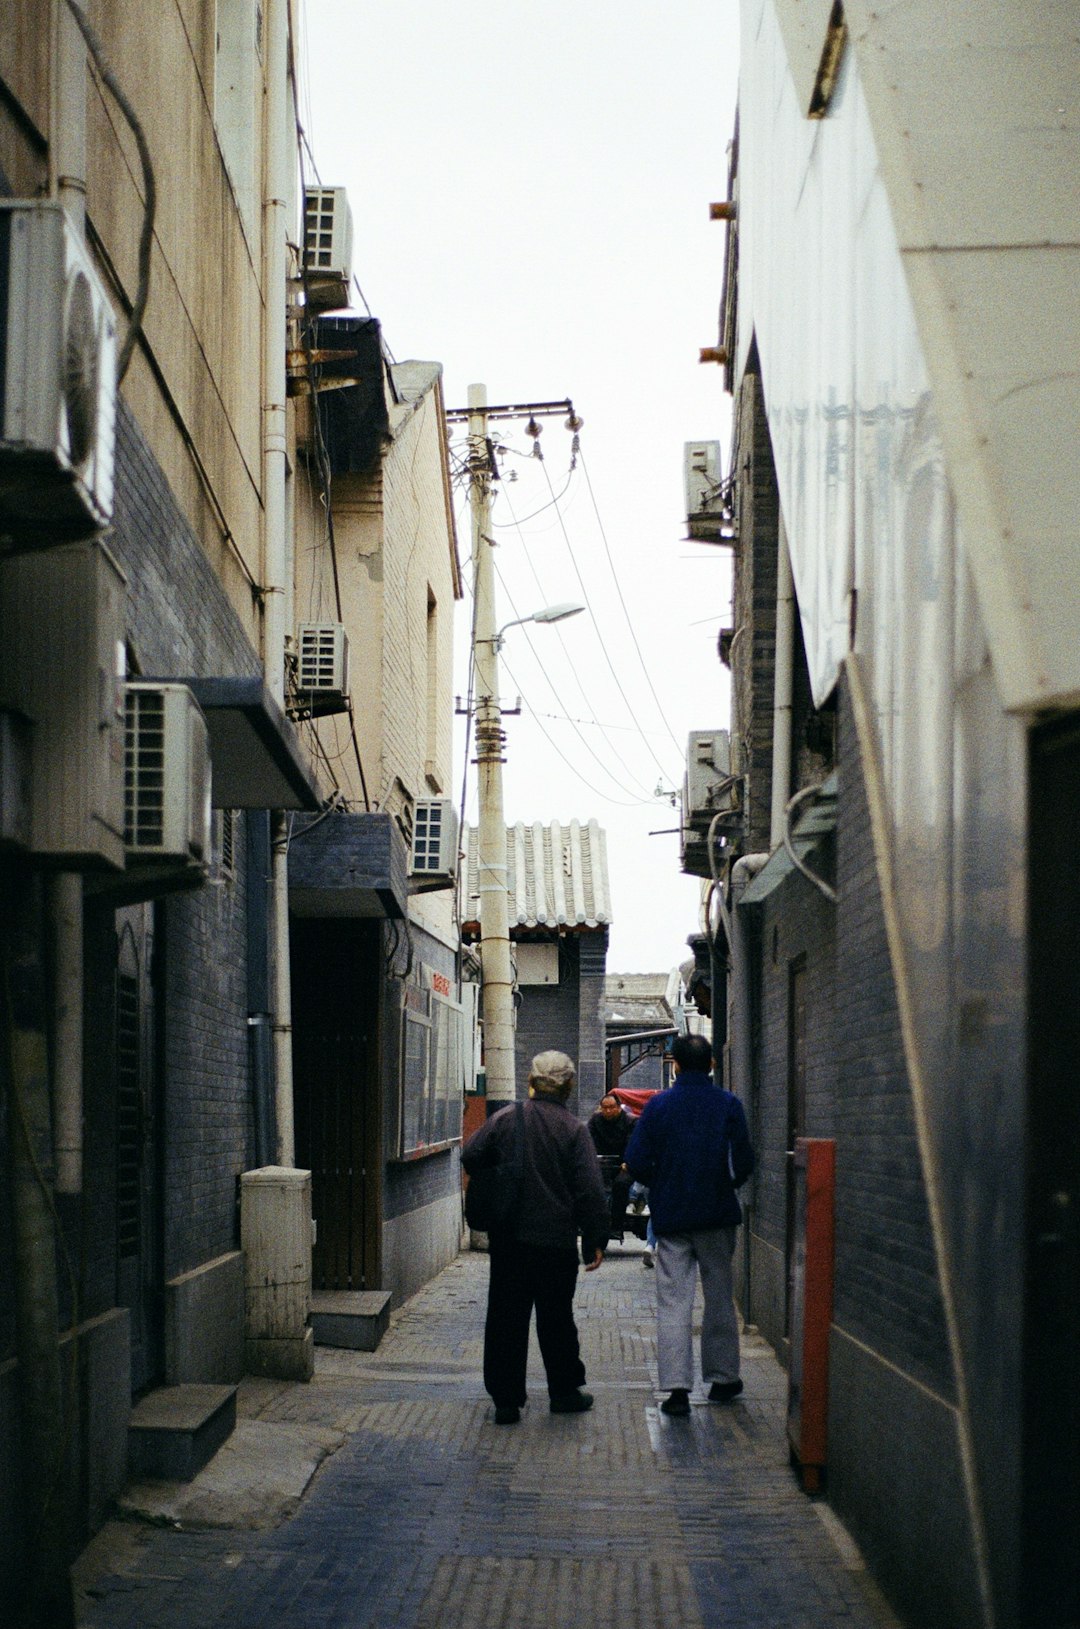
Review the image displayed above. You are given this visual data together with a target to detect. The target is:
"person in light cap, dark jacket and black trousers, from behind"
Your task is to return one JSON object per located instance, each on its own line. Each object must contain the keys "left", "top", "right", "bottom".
{"left": 461, "top": 1052, "right": 608, "bottom": 1425}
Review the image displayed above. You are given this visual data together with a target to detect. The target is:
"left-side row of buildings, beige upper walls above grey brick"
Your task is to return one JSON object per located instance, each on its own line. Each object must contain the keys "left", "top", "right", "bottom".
{"left": 0, "top": 0, "right": 468, "bottom": 1622}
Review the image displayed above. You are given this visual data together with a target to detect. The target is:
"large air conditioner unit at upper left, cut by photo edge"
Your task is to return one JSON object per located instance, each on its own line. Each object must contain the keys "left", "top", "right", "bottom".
{"left": 0, "top": 199, "right": 117, "bottom": 544}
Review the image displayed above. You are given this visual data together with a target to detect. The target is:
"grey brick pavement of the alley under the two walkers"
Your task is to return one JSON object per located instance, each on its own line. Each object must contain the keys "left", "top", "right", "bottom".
{"left": 78, "top": 1243, "right": 896, "bottom": 1629}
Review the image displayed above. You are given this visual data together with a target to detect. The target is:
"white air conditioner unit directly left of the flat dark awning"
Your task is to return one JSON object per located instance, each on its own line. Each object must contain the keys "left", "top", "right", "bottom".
{"left": 124, "top": 679, "right": 210, "bottom": 870}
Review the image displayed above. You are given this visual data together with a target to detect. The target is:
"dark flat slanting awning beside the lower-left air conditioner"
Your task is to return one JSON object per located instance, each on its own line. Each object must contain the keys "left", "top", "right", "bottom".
{"left": 174, "top": 676, "right": 323, "bottom": 810}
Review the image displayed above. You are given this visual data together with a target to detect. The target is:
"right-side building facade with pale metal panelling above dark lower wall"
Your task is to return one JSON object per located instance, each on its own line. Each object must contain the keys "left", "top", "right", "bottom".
{"left": 693, "top": 0, "right": 1080, "bottom": 1629}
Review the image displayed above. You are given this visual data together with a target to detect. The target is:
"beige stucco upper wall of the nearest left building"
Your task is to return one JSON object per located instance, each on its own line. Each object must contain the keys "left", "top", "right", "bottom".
{"left": 0, "top": 0, "right": 283, "bottom": 650}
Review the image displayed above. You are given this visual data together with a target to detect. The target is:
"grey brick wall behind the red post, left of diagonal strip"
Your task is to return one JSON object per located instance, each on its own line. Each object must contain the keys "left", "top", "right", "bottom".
{"left": 751, "top": 674, "right": 953, "bottom": 1398}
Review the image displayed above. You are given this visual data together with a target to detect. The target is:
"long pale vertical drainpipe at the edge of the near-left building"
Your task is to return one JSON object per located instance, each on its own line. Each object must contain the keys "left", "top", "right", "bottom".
{"left": 262, "top": 0, "right": 295, "bottom": 1166}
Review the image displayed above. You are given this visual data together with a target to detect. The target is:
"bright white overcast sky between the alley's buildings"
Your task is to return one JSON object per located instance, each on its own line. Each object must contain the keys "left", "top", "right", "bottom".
{"left": 301, "top": 0, "right": 738, "bottom": 973}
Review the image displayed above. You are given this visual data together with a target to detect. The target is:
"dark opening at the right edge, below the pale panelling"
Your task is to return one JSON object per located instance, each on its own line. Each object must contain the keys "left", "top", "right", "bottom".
{"left": 1020, "top": 714, "right": 1080, "bottom": 1629}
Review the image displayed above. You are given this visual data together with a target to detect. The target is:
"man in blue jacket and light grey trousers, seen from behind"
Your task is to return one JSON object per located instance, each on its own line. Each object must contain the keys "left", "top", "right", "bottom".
{"left": 626, "top": 1034, "right": 754, "bottom": 1414}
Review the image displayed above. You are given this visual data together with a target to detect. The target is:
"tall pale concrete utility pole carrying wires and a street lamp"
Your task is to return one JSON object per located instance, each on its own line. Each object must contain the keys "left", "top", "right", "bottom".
{"left": 469, "top": 384, "right": 516, "bottom": 1114}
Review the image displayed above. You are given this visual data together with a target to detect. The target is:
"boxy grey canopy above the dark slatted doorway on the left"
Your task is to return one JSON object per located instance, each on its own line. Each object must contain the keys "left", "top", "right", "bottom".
{"left": 288, "top": 810, "right": 409, "bottom": 919}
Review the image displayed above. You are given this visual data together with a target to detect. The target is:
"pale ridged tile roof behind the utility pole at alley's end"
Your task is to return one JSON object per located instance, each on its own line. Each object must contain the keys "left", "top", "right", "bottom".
{"left": 461, "top": 819, "right": 611, "bottom": 932}
